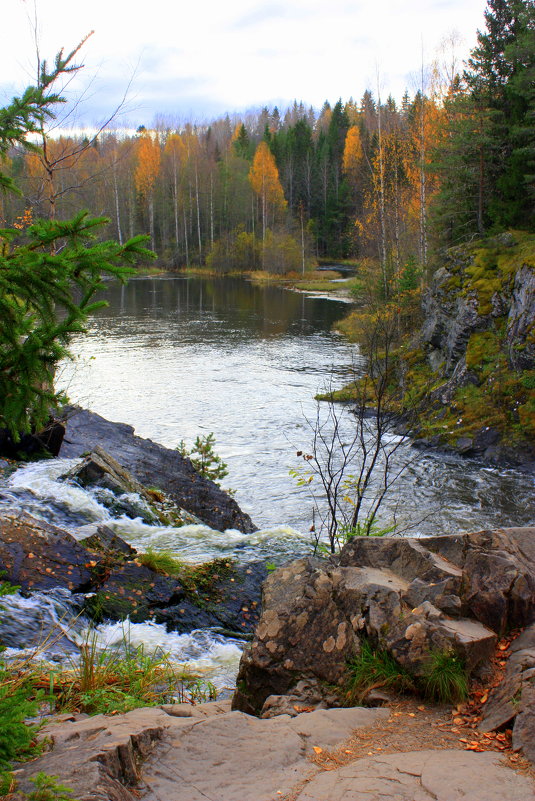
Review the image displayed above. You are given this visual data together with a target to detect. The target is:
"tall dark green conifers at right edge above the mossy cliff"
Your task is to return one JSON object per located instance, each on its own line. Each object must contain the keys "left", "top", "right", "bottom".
{"left": 434, "top": 0, "right": 535, "bottom": 244}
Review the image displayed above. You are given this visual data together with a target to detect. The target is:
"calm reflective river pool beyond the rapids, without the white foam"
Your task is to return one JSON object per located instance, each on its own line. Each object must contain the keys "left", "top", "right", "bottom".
{"left": 56, "top": 276, "right": 534, "bottom": 534}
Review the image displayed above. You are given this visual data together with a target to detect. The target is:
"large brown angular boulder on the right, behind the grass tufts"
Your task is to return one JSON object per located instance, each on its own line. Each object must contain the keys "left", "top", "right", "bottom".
{"left": 233, "top": 529, "right": 535, "bottom": 714}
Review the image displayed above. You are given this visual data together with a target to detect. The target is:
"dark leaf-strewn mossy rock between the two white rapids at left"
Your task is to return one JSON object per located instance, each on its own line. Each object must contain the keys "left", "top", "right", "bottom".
{"left": 0, "top": 511, "right": 267, "bottom": 634}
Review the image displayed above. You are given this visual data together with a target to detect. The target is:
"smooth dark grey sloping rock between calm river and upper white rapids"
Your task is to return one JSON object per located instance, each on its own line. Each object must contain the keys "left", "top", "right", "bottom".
{"left": 60, "top": 407, "right": 256, "bottom": 533}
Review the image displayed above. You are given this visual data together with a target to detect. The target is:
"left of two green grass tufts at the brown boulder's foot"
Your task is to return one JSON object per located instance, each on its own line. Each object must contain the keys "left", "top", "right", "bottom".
{"left": 346, "top": 640, "right": 414, "bottom": 704}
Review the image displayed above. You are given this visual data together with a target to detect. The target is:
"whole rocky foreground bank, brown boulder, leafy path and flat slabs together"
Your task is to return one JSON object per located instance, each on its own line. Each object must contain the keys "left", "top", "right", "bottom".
{"left": 4, "top": 529, "right": 535, "bottom": 801}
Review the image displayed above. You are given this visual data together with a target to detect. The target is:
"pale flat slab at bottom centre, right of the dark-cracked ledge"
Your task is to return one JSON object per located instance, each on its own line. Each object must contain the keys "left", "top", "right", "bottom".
{"left": 143, "top": 708, "right": 389, "bottom": 801}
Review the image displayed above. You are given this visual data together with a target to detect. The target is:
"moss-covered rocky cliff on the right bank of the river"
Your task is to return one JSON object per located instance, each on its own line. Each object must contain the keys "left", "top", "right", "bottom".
{"left": 402, "top": 233, "right": 535, "bottom": 467}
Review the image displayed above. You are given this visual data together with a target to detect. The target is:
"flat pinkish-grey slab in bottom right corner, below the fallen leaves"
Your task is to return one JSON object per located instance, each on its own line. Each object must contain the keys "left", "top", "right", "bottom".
{"left": 296, "top": 750, "right": 535, "bottom": 801}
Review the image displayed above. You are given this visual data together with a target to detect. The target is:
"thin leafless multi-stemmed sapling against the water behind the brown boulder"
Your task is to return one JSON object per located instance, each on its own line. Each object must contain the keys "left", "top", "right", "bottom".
{"left": 292, "top": 310, "right": 417, "bottom": 553}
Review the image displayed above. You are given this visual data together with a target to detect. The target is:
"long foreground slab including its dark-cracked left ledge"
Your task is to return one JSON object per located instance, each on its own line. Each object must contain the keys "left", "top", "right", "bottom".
{"left": 13, "top": 703, "right": 389, "bottom": 801}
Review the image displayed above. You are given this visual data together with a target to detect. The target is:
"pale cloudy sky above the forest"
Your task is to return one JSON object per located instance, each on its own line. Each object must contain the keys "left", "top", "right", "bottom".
{"left": 0, "top": 0, "right": 486, "bottom": 127}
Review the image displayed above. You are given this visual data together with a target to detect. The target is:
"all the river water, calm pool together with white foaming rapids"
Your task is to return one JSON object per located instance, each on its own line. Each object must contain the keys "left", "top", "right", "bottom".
{"left": 0, "top": 276, "right": 535, "bottom": 686}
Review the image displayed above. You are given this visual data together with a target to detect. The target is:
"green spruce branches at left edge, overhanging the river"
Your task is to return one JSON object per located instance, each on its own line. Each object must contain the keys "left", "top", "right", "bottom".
{"left": 0, "top": 48, "right": 151, "bottom": 440}
